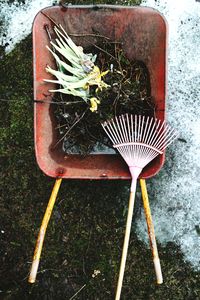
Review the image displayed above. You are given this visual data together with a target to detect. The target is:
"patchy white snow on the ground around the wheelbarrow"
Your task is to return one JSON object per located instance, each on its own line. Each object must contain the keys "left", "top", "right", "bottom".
{"left": 0, "top": 0, "right": 200, "bottom": 270}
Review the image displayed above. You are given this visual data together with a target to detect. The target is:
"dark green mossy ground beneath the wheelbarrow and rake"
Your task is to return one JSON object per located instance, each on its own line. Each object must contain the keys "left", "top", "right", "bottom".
{"left": 0, "top": 1, "right": 200, "bottom": 300}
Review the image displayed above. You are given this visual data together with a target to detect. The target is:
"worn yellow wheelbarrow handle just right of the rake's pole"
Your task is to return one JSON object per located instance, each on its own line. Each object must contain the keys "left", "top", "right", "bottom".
{"left": 140, "top": 179, "right": 163, "bottom": 284}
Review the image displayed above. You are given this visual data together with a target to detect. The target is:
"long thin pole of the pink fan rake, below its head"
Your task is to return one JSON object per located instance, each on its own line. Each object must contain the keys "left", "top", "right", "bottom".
{"left": 115, "top": 179, "right": 137, "bottom": 300}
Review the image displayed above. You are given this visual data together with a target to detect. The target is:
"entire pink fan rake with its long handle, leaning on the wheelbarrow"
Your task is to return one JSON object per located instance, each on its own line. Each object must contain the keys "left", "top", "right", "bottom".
{"left": 102, "top": 114, "right": 177, "bottom": 300}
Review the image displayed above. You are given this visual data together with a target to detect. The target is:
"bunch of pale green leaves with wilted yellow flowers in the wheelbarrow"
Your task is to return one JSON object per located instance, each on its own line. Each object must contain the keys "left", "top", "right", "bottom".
{"left": 44, "top": 25, "right": 109, "bottom": 112}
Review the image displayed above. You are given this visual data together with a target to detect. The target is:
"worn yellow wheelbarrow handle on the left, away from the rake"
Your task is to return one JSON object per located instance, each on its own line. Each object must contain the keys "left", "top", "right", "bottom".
{"left": 28, "top": 178, "right": 62, "bottom": 283}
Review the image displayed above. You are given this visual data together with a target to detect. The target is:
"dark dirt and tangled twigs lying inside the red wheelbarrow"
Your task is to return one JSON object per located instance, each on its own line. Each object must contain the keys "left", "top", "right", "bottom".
{"left": 50, "top": 37, "right": 155, "bottom": 155}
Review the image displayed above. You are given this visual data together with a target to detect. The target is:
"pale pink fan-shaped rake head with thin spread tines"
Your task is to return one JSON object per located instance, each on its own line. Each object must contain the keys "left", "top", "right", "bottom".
{"left": 102, "top": 114, "right": 177, "bottom": 185}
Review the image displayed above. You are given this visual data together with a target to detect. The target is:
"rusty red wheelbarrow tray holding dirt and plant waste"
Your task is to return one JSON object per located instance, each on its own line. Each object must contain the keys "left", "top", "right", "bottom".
{"left": 33, "top": 5, "right": 166, "bottom": 179}
